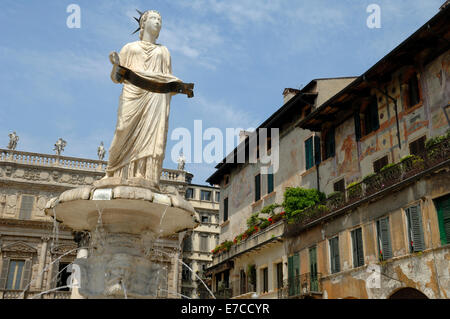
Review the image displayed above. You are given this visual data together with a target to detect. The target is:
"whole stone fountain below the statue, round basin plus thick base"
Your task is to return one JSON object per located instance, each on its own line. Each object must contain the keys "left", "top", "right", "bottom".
{"left": 45, "top": 180, "right": 199, "bottom": 298}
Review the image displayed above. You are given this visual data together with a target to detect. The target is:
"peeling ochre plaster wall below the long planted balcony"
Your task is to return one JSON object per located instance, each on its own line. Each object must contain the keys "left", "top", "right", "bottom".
{"left": 285, "top": 171, "right": 450, "bottom": 298}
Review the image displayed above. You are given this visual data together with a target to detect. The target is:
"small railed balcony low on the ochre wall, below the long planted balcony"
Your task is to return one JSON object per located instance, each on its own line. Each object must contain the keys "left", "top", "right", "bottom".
{"left": 278, "top": 273, "right": 322, "bottom": 299}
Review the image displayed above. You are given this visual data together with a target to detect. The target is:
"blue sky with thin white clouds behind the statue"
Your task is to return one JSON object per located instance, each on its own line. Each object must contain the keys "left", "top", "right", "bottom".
{"left": 0, "top": 0, "right": 444, "bottom": 184}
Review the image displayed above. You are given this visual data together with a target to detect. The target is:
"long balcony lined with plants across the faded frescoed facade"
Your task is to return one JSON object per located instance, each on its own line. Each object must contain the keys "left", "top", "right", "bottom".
{"left": 284, "top": 134, "right": 450, "bottom": 237}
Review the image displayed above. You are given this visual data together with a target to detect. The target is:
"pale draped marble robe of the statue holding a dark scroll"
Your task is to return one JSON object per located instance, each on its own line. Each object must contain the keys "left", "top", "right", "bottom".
{"left": 106, "top": 41, "right": 181, "bottom": 185}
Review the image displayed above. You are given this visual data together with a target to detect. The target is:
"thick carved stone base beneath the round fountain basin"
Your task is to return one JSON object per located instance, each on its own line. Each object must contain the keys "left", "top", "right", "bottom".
{"left": 74, "top": 234, "right": 167, "bottom": 298}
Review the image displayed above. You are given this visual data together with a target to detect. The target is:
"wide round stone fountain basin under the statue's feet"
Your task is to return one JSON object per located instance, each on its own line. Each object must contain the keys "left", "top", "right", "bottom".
{"left": 45, "top": 186, "right": 199, "bottom": 237}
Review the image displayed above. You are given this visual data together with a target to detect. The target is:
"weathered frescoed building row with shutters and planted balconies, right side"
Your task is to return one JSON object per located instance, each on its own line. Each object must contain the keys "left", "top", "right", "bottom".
{"left": 207, "top": 6, "right": 450, "bottom": 299}
